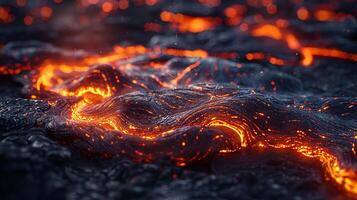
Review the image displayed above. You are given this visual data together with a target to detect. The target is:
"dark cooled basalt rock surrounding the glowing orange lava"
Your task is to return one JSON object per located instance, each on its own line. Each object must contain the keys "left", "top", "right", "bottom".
{"left": 0, "top": 1, "right": 357, "bottom": 200}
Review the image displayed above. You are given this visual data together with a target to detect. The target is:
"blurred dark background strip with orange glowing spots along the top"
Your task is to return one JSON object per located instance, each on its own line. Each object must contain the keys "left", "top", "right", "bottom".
{"left": 0, "top": 0, "right": 357, "bottom": 49}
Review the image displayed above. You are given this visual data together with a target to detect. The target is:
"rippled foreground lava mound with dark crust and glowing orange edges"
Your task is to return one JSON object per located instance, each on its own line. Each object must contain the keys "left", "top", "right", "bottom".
{"left": 21, "top": 43, "right": 357, "bottom": 193}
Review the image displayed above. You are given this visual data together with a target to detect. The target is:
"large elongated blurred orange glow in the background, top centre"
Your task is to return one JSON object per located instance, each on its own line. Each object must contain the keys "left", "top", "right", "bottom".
{"left": 160, "top": 11, "right": 221, "bottom": 33}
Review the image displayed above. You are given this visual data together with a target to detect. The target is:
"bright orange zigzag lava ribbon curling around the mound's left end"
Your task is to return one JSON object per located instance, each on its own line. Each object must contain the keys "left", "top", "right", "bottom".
{"left": 32, "top": 45, "right": 208, "bottom": 131}
